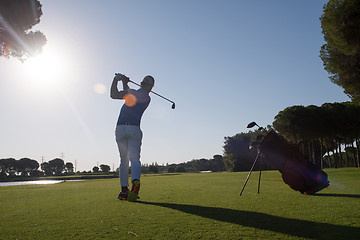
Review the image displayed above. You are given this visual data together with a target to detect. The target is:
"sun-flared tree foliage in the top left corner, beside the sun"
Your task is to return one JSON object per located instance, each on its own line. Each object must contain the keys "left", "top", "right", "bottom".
{"left": 0, "top": 0, "right": 46, "bottom": 61}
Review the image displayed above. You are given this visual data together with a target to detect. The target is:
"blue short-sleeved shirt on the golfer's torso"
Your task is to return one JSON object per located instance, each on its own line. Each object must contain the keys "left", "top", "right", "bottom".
{"left": 117, "top": 88, "right": 151, "bottom": 126}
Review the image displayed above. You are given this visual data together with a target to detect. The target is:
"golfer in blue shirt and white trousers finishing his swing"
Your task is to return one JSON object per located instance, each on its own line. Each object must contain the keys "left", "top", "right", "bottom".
{"left": 110, "top": 74, "right": 155, "bottom": 202}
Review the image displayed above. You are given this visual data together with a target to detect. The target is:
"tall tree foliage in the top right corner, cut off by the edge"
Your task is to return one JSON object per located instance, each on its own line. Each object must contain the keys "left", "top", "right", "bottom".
{"left": 320, "top": 0, "right": 360, "bottom": 102}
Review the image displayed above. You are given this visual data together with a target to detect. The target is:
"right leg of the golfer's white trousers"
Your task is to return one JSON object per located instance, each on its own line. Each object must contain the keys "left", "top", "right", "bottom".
{"left": 129, "top": 127, "right": 142, "bottom": 181}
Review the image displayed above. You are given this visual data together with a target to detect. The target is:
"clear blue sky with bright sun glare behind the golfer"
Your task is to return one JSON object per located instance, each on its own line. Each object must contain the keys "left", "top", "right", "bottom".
{"left": 0, "top": 0, "right": 349, "bottom": 171}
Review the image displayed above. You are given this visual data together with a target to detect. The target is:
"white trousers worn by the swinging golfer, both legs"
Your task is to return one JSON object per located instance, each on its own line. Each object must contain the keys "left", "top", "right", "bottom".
{"left": 115, "top": 125, "right": 142, "bottom": 187}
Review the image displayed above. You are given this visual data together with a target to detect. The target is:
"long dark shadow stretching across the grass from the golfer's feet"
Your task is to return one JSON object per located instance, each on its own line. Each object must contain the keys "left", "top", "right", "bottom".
{"left": 138, "top": 201, "right": 360, "bottom": 239}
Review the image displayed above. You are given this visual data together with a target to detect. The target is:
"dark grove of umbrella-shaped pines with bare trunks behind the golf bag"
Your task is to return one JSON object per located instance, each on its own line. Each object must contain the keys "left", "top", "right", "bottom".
{"left": 273, "top": 102, "right": 360, "bottom": 167}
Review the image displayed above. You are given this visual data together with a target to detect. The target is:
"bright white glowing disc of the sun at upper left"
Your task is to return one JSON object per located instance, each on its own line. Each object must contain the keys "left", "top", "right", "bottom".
{"left": 24, "top": 45, "right": 69, "bottom": 90}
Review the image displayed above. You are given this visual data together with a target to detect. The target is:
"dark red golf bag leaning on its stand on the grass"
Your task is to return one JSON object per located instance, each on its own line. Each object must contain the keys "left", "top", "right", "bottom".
{"left": 259, "top": 131, "right": 329, "bottom": 194}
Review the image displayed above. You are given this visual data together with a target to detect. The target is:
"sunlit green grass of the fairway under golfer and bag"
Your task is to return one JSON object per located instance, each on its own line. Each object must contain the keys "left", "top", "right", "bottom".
{"left": 0, "top": 168, "right": 360, "bottom": 240}
